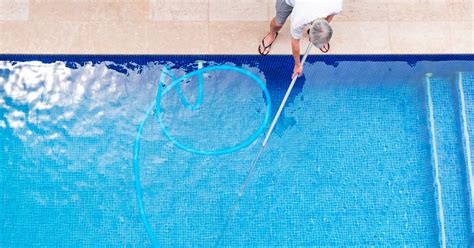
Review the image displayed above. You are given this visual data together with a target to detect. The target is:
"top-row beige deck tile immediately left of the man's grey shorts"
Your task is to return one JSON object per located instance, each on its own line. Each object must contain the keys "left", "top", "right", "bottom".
{"left": 209, "top": 0, "right": 268, "bottom": 22}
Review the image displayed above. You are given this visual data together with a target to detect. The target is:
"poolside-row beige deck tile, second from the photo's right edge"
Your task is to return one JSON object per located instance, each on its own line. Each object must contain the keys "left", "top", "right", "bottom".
{"left": 390, "top": 21, "right": 451, "bottom": 54}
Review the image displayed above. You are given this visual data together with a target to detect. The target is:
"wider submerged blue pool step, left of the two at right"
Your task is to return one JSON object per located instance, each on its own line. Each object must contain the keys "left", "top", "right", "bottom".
{"left": 424, "top": 73, "right": 470, "bottom": 247}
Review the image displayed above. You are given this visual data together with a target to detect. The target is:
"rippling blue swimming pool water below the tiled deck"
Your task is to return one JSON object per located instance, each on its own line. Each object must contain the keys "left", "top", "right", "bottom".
{"left": 0, "top": 55, "right": 474, "bottom": 247}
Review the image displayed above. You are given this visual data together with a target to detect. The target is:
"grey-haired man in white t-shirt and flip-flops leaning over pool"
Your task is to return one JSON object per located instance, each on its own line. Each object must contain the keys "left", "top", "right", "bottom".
{"left": 258, "top": 0, "right": 342, "bottom": 78}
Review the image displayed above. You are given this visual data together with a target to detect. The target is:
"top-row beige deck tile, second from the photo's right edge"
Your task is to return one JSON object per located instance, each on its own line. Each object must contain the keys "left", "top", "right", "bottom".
{"left": 388, "top": 0, "right": 448, "bottom": 21}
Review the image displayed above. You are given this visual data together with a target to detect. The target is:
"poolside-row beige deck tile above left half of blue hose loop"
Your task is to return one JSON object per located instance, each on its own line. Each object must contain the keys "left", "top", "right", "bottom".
{"left": 148, "top": 22, "right": 209, "bottom": 54}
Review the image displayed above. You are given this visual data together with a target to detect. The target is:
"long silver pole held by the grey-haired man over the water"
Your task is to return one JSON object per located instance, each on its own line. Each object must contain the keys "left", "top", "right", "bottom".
{"left": 239, "top": 42, "right": 313, "bottom": 198}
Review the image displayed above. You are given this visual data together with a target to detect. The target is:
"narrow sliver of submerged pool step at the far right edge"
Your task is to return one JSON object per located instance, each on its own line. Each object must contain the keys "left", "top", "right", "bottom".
{"left": 456, "top": 72, "right": 474, "bottom": 244}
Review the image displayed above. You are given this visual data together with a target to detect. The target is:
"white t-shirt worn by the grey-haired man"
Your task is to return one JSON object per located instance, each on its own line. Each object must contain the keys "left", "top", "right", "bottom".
{"left": 285, "top": 0, "right": 342, "bottom": 39}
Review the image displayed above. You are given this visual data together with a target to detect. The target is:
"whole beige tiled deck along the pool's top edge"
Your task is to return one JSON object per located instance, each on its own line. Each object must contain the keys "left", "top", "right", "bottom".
{"left": 0, "top": 0, "right": 474, "bottom": 54}
